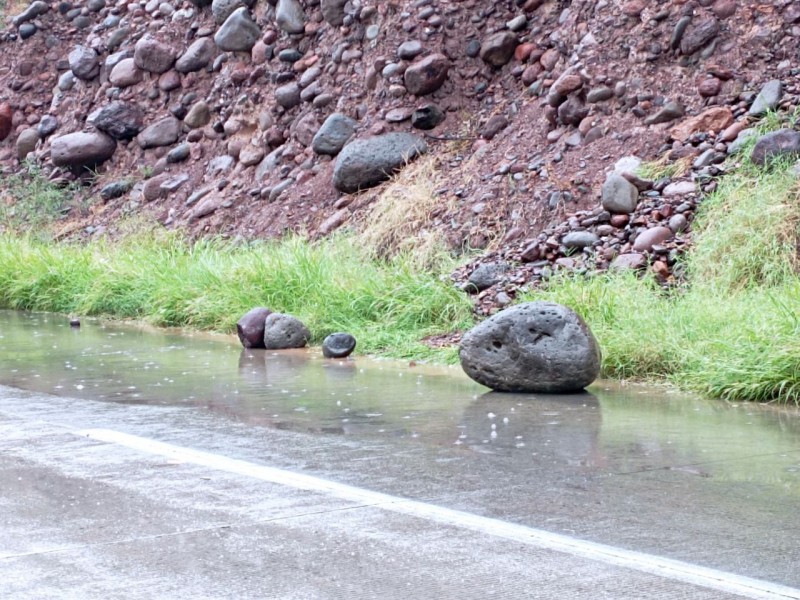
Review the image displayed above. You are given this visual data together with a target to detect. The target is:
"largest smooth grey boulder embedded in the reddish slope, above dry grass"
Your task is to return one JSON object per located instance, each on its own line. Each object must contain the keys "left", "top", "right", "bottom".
{"left": 333, "top": 133, "right": 428, "bottom": 194}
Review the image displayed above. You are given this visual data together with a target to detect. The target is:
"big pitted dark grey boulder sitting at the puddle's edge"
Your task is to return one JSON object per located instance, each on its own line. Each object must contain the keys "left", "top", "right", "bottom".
{"left": 459, "top": 302, "right": 600, "bottom": 393}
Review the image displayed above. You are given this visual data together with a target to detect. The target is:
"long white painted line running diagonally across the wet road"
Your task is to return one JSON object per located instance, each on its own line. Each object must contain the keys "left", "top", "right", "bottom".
{"left": 76, "top": 429, "right": 800, "bottom": 600}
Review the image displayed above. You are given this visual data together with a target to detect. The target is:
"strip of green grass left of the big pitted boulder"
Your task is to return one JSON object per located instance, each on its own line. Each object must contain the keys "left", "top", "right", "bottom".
{"left": 0, "top": 234, "right": 472, "bottom": 362}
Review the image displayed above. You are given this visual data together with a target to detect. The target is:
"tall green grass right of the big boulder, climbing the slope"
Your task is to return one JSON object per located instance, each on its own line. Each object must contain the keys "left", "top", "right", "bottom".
{"left": 526, "top": 129, "right": 800, "bottom": 404}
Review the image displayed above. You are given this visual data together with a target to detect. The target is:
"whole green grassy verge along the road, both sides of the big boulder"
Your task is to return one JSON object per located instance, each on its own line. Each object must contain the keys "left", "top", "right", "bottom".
{"left": 0, "top": 125, "right": 800, "bottom": 404}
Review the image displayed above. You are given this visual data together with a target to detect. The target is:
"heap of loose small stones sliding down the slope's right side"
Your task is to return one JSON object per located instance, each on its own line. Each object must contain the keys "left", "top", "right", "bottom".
{"left": 453, "top": 76, "right": 800, "bottom": 314}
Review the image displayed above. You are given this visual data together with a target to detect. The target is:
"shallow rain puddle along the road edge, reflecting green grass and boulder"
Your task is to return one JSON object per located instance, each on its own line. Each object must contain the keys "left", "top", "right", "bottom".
{"left": 0, "top": 311, "right": 800, "bottom": 493}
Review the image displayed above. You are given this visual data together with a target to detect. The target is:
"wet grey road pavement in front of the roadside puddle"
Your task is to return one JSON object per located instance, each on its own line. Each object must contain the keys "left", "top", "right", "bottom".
{"left": 0, "top": 388, "right": 800, "bottom": 599}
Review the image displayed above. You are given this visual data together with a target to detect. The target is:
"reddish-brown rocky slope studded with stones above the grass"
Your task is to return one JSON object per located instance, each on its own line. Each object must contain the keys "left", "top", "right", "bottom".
{"left": 0, "top": 0, "right": 800, "bottom": 311}
